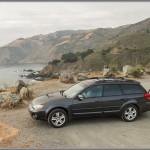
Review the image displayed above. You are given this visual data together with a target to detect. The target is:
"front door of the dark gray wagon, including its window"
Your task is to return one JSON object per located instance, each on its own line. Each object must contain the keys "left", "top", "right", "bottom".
{"left": 72, "top": 85, "right": 103, "bottom": 116}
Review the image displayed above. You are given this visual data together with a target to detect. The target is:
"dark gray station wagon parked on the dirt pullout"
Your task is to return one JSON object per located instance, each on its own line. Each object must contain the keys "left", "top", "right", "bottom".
{"left": 29, "top": 79, "right": 150, "bottom": 128}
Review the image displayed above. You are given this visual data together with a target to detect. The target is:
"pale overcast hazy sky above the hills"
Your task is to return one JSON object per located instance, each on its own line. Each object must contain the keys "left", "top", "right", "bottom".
{"left": 0, "top": 2, "right": 150, "bottom": 46}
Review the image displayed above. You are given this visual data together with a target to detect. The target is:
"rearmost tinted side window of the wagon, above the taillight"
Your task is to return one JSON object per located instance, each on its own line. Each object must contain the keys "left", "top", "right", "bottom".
{"left": 121, "top": 84, "right": 144, "bottom": 94}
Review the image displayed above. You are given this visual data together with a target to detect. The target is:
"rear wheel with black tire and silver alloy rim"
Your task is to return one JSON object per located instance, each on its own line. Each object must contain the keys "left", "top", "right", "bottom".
{"left": 121, "top": 104, "right": 138, "bottom": 122}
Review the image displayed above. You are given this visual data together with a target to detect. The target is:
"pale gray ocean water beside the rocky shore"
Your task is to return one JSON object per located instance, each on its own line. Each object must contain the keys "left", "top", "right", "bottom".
{"left": 0, "top": 64, "right": 47, "bottom": 88}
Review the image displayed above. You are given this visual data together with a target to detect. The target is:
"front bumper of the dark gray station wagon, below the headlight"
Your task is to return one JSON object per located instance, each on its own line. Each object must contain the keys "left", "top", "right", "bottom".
{"left": 28, "top": 104, "right": 47, "bottom": 120}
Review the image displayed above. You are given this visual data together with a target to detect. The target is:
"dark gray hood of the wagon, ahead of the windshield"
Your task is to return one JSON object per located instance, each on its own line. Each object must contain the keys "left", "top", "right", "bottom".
{"left": 32, "top": 92, "right": 66, "bottom": 105}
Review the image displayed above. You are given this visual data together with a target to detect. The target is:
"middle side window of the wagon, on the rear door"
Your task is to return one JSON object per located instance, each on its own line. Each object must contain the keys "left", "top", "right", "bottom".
{"left": 104, "top": 85, "right": 122, "bottom": 96}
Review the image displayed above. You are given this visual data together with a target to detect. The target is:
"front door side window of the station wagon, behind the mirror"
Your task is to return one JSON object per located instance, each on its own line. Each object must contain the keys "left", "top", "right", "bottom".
{"left": 81, "top": 85, "right": 103, "bottom": 98}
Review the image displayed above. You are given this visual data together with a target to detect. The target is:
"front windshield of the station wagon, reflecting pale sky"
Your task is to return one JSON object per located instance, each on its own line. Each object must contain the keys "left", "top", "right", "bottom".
{"left": 63, "top": 83, "right": 84, "bottom": 98}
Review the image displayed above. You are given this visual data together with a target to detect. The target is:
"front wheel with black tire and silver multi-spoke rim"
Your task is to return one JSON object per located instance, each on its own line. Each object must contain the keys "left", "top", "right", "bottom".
{"left": 48, "top": 109, "right": 68, "bottom": 128}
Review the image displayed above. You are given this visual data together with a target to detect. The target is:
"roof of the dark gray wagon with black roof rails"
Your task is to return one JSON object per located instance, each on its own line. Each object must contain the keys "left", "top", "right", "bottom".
{"left": 80, "top": 78, "right": 140, "bottom": 86}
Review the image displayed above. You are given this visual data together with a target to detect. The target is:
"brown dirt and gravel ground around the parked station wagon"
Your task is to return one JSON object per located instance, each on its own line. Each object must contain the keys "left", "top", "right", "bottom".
{"left": 0, "top": 76, "right": 150, "bottom": 148}
